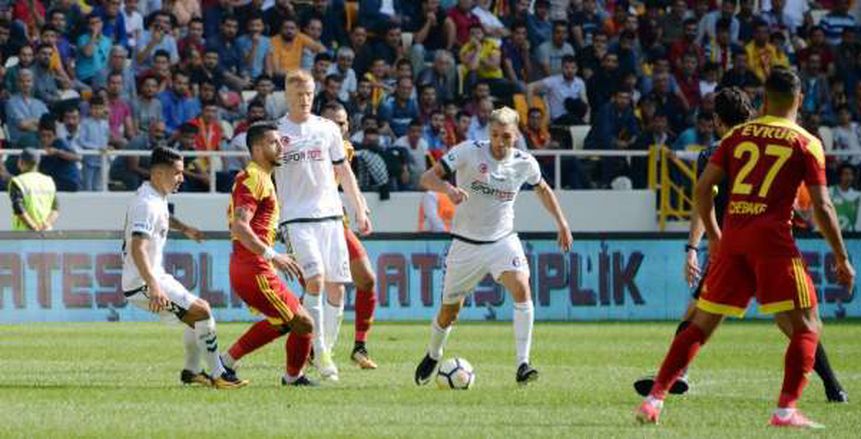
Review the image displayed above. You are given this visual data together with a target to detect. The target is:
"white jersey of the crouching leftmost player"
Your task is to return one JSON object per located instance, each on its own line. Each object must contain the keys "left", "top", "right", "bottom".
{"left": 123, "top": 182, "right": 170, "bottom": 291}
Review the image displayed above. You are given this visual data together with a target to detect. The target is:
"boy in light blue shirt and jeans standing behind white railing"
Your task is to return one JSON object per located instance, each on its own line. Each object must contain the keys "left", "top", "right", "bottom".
{"left": 77, "top": 96, "right": 110, "bottom": 191}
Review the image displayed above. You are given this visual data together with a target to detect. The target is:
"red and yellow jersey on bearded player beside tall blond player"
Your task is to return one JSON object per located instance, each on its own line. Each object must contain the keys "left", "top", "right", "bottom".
{"left": 227, "top": 162, "right": 279, "bottom": 257}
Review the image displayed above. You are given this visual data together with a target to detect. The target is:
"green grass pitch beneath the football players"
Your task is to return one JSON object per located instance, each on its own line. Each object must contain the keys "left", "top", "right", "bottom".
{"left": 0, "top": 322, "right": 861, "bottom": 438}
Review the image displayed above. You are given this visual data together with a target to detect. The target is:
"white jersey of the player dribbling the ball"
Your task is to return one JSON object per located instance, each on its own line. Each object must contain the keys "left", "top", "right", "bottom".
{"left": 440, "top": 142, "right": 541, "bottom": 242}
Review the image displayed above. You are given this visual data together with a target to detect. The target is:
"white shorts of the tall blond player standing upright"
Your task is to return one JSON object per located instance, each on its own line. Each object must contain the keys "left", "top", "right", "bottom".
{"left": 287, "top": 220, "right": 353, "bottom": 283}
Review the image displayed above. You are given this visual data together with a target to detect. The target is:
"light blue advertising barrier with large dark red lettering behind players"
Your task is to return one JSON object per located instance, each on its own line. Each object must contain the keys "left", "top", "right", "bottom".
{"left": 0, "top": 233, "right": 861, "bottom": 323}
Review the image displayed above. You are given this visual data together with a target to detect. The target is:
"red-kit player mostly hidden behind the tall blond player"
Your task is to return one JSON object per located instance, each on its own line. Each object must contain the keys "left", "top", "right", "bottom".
{"left": 322, "top": 103, "right": 377, "bottom": 369}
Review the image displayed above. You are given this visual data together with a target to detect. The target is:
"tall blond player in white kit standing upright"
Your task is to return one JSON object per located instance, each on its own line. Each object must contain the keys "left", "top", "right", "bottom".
{"left": 274, "top": 70, "right": 371, "bottom": 381}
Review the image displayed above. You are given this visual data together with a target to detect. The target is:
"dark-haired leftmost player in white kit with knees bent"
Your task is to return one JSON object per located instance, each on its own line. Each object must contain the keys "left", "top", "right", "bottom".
{"left": 122, "top": 147, "right": 248, "bottom": 389}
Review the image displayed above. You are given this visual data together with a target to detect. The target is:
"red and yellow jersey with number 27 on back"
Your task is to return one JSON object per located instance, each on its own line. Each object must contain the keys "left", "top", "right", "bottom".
{"left": 710, "top": 116, "right": 826, "bottom": 255}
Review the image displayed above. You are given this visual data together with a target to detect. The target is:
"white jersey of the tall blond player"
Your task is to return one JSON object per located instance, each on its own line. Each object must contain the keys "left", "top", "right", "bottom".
{"left": 275, "top": 115, "right": 346, "bottom": 222}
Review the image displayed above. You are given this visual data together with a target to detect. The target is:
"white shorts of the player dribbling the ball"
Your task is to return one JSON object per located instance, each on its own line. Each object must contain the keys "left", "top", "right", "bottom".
{"left": 442, "top": 235, "right": 529, "bottom": 305}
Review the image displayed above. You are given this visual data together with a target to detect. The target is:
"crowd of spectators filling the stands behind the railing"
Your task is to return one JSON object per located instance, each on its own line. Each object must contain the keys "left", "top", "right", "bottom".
{"left": 0, "top": 0, "right": 861, "bottom": 192}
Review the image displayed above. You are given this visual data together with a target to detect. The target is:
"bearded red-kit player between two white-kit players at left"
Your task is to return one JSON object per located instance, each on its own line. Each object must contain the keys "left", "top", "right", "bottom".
{"left": 221, "top": 124, "right": 314, "bottom": 386}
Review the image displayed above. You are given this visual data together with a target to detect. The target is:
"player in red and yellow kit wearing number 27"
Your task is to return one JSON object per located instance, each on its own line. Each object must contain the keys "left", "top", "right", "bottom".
{"left": 636, "top": 68, "right": 855, "bottom": 428}
